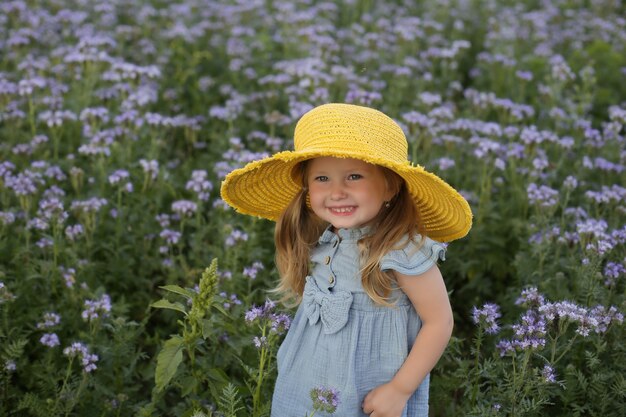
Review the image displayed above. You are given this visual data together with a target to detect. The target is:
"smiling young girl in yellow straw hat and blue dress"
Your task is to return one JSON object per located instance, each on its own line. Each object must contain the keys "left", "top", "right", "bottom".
{"left": 221, "top": 104, "right": 472, "bottom": 417}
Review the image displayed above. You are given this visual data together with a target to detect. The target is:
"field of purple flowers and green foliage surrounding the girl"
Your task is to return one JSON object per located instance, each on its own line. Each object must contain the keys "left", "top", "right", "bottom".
{"left": 0, "top": 0, "right": 626, "bottom": 417}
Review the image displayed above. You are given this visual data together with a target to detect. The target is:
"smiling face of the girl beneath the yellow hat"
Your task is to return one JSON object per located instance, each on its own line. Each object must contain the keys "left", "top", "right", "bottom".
{"left": 306, "top": 157, "right": 393, "bottom": 229}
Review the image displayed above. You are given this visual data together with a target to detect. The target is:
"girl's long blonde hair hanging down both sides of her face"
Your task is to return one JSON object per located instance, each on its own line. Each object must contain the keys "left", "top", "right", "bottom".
{"left": 274, "top": 161, "right": 423, "bottom": 305}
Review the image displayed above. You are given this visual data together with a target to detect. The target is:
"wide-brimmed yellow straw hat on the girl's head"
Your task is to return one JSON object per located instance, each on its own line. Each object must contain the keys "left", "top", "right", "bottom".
{"left": 221, "top": 103, "right": 472, "bottom": 242}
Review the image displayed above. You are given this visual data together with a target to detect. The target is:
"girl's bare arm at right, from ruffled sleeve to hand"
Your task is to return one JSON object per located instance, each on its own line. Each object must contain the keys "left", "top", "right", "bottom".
{"left": 363, "top": 265, "right": 454, "bottom": 417}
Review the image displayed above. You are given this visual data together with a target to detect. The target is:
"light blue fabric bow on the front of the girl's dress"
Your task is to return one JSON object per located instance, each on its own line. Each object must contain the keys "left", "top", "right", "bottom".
{"left": 302, "top": 276, "right": 352, "bottom": 334}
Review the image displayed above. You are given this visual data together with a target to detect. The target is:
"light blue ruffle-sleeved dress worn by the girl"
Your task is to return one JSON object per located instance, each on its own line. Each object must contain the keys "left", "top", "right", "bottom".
{"left": 271, "top": 229, "right": 445, "bottom": 417}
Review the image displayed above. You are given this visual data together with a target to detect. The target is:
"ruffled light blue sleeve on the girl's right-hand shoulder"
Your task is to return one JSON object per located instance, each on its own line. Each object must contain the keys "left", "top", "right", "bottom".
{"left": 380, "top": 235, "right": 446, "bottom": 275}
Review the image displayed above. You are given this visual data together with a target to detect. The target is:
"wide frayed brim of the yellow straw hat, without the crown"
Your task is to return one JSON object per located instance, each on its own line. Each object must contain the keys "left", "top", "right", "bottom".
{"left": 221, "top": 150, "right": 472, "bottom": 242}
